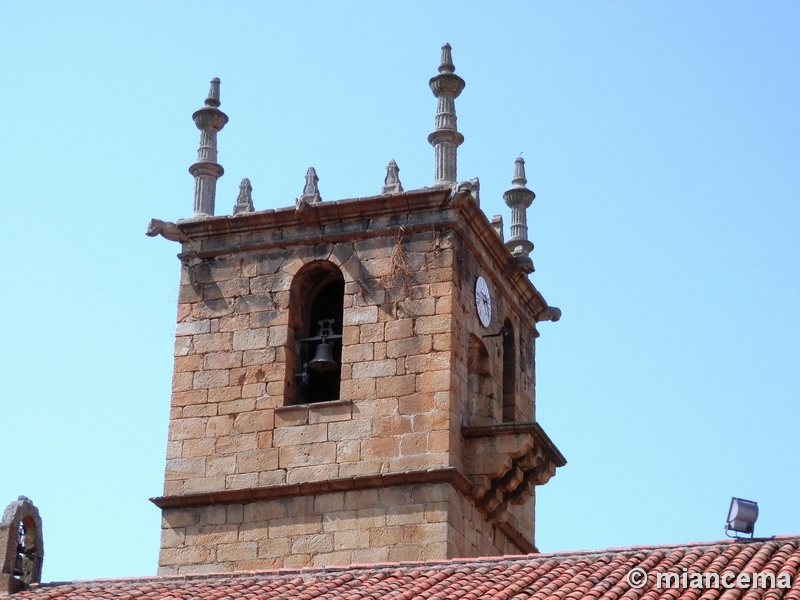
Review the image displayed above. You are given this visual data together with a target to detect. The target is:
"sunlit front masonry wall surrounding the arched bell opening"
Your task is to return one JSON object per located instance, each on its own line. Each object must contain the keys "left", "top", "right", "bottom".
{"left": 164, "top": 230, "right": 460, "bottom": 495}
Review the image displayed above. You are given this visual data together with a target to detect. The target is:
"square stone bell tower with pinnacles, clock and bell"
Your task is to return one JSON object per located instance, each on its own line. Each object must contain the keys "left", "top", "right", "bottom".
{"left": 148, "top": 46, "right": 565, "bottom": 573}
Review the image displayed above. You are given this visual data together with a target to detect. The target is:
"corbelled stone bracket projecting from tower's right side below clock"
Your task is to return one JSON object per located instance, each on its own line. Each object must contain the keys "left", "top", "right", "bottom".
{"left": 461, "top": 423, "right": 567, "bottom": 525}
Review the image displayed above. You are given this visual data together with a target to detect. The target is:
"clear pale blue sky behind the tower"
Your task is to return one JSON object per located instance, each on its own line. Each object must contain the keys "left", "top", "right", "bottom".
{"left": 0, "top": 0, "right": 800, "bottom": 580}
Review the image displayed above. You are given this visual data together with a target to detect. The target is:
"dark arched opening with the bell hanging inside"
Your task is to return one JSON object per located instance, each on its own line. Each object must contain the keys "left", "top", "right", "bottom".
{"left": 286, "top": 261, "right": 344, "bottom": 404}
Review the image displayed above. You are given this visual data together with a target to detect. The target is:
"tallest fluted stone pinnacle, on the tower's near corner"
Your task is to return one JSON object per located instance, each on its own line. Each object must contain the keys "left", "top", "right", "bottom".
{"left": 428, "top": 44, "right": 466, "bottom": 186}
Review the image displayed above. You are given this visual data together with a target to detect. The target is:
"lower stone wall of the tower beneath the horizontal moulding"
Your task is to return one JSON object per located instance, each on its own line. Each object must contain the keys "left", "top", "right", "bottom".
{"left": 158, "top": 483, "right": 519, "bottom": 575}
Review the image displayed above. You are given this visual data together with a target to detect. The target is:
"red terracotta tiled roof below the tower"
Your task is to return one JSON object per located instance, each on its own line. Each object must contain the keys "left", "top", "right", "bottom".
{"left": 17, "top": 537, "right": 800, "bottom": 600}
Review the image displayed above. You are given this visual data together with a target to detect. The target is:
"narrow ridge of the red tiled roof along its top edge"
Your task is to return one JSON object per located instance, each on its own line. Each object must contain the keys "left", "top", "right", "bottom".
{"left": 31, "top": 535, "right": 800, "bottom": 588}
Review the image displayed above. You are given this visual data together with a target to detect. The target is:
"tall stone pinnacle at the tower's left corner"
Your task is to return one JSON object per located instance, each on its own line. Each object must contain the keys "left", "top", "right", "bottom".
{"left": 189, "top": 77, "right": 228, "bottom": 218}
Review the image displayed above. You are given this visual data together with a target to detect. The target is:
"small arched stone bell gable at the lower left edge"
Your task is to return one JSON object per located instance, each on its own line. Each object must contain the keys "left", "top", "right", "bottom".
{"left": 0, "top": 496, "right": 44, "bottom": 595}
